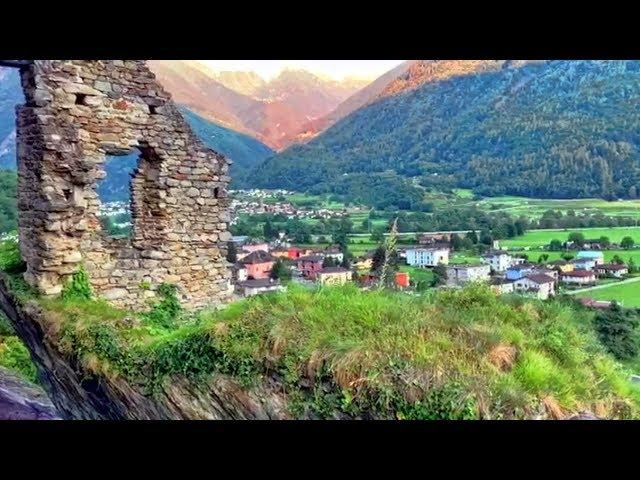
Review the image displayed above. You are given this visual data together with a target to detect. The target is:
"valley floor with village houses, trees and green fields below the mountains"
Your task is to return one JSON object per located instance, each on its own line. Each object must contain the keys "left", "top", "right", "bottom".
{"left": 94, "top": 189, "right": 640, "bottom": 308}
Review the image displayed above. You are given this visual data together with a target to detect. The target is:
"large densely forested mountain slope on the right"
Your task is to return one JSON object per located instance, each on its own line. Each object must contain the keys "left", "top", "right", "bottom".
{"left": 250, "top": 61, "right": 640, "bottom": 206}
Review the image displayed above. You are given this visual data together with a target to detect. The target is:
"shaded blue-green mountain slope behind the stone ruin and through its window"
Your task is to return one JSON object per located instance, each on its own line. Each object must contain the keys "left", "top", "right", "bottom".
{"left": 0, "top": 68, "right": 274, "bottom": 201}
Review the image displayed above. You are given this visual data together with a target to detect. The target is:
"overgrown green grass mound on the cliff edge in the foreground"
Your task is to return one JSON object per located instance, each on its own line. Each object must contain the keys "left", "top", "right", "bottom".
{"left": 1, "top": 242, "right": 640, "bottom": 419}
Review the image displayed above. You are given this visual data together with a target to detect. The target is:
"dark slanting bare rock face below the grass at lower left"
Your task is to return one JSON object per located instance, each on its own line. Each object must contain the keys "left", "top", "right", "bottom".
{"left": 0, "top": 279, "right": 289, "bottom": 420}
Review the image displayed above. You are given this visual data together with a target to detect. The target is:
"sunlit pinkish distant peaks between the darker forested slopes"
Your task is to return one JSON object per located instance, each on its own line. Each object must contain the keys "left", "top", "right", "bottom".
{"left": 149, "top": 60, "right": 369, "bottom": 150}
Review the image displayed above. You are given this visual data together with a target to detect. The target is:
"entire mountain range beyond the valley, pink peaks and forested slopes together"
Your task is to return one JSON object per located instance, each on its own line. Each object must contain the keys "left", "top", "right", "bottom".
{"left": 5, "top": 60, "right": 640, "bottom": 209}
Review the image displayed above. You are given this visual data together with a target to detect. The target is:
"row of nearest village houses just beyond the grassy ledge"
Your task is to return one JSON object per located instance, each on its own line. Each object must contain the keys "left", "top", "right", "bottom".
{"left": 228, "top": 214, "right": 640, "bottom": 308}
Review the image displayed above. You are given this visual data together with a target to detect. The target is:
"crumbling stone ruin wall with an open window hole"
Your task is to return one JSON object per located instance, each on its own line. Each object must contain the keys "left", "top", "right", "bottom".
{"left": 17, "top": 60, "right": 230, "bottom": 308}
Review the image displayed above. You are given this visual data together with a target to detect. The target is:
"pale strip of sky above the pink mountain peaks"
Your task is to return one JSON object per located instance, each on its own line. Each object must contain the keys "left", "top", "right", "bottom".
{"left": 201, "top": 60, "right": 404, "bottom": 80}
